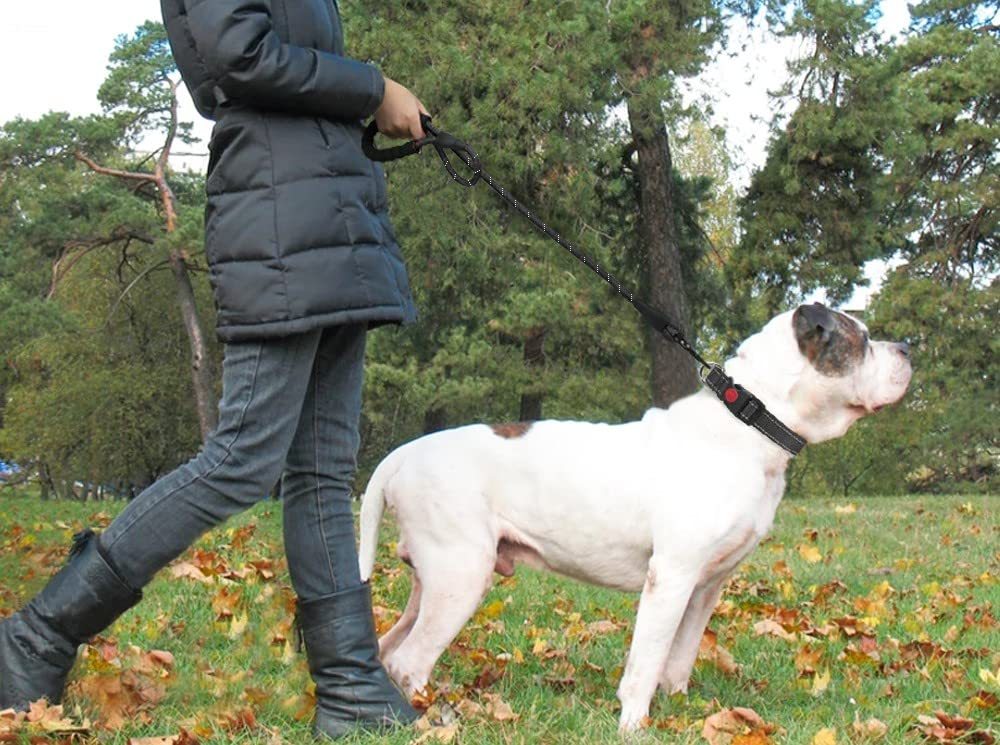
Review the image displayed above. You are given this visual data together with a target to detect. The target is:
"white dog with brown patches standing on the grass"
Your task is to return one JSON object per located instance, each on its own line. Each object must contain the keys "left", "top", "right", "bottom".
{"left": 360, "top": 303, "right": 911, "bottom": 731}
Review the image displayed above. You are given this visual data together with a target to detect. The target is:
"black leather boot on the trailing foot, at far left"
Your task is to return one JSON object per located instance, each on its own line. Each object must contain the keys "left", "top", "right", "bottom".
{"left": 0, "top": 529, "right": 142, "bottom": 711}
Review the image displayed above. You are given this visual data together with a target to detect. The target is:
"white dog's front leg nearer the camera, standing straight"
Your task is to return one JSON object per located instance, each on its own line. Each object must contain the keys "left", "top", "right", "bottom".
{"left": 618, "top": 554, "right": 696, "bottom": 732}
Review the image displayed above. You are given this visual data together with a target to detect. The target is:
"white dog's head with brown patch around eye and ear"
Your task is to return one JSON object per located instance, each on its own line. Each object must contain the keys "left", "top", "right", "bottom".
{"left": 726, "top": 303, "right": 912, "bottom": 442}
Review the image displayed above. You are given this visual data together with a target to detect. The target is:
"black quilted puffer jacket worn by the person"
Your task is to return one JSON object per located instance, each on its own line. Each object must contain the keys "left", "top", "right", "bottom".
{"left": 161, "top": 0, "right": 416, "bottom": 342}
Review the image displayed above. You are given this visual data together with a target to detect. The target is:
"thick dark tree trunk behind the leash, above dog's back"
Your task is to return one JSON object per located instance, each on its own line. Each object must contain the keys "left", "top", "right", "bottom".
{"left": 628, "top": 99, "right": 698, "bottom": 408}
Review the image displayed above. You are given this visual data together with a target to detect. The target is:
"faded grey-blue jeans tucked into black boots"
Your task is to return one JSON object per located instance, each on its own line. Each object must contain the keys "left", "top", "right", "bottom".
{"left": 100, "top": 324, "right": 367, "bottom": 600}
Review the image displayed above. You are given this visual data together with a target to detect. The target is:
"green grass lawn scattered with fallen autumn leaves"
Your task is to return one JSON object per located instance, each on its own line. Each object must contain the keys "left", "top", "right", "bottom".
{"left": 0, "top": 496, "right": 1000, "bottom": 745}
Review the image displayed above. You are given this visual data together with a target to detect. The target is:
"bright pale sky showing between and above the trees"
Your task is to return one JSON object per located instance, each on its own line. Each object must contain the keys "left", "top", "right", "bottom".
{"left": 0, "top": 0, "right": 909, "bottom": 308}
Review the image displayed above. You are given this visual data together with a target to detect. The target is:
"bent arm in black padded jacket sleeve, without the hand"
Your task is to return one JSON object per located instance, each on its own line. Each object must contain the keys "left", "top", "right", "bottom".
{"left": 186, "top": 0, "right": 386, "bottom": 119}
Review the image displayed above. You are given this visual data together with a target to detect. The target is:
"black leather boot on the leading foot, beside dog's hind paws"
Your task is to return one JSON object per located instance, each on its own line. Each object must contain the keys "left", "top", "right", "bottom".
{"left": 296, "top": 582, "right": 419, "bottom": 738}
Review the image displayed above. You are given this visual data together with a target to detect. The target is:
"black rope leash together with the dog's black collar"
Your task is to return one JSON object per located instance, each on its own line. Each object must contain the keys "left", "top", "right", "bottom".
{"left": 361, "top": 114, "right": 806, "bottom": 455}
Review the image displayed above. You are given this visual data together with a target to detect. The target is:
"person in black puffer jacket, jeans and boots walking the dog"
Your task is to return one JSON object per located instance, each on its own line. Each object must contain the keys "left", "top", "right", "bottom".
{"left": 0, "top": 0, "right": 427, "bottom": 738}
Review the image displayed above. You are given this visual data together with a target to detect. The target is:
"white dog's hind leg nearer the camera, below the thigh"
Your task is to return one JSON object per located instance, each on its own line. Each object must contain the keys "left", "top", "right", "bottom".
{"left": 383, "top": 547, "right": 496, "bottom": 696}
